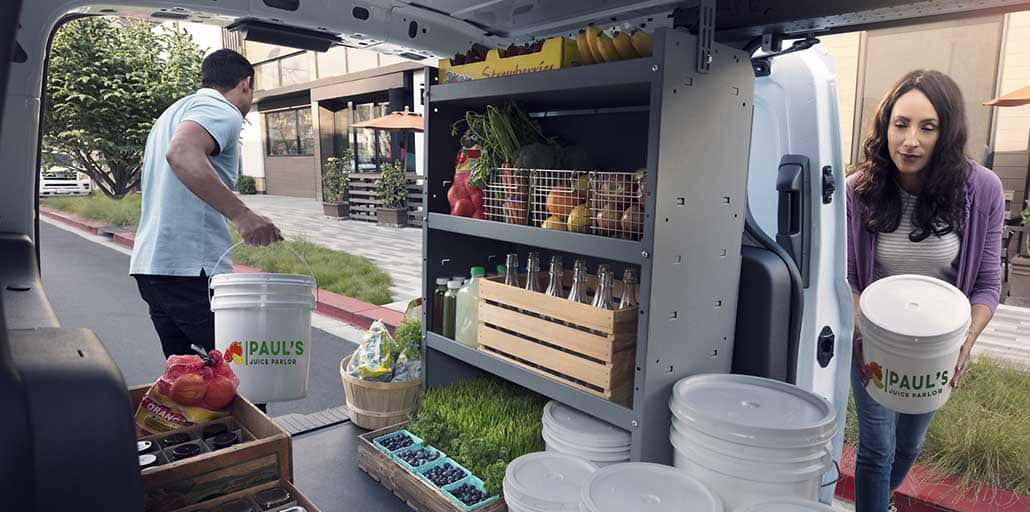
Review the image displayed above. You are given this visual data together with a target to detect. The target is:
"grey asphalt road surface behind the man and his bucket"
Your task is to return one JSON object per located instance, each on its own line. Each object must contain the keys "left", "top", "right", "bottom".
{"left": 39, "top": 221, "right": 356, "bottom": 416}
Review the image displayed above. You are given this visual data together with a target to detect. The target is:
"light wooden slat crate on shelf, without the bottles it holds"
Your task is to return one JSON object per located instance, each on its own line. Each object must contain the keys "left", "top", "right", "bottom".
{"left": 478, "top": 278, "right": 639, "bottom": 405}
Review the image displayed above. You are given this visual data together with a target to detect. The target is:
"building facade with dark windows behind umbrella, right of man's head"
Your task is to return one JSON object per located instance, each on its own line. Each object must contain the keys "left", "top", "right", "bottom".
{"left": 225, "top": 33, "right": 424, "bottom": 200}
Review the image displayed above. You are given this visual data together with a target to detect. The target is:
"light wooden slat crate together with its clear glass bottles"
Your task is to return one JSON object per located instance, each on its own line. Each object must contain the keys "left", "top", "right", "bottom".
{"left": 477, "top": 252, "right": 640, "bottom": 405}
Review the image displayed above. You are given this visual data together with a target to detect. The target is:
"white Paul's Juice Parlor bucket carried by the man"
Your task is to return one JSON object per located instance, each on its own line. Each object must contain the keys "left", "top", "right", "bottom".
{"left": 211, "top": 273, "right": 315, "bottom": 403}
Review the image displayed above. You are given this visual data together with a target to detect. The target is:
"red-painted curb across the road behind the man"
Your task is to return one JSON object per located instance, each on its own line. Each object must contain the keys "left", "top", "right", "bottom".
{"left": 39, "top": 206, "right": 404, "bottom": 331}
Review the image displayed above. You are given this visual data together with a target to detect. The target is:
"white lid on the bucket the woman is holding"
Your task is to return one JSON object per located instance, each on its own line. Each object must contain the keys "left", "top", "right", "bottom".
{"left": 859, "top": 275, "right": 970, "bottom": 342}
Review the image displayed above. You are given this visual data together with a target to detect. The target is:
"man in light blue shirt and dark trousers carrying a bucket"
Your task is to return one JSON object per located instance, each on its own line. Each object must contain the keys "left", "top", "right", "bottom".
{"left": 129, "top": 49, "right": 282, "bottom": 357}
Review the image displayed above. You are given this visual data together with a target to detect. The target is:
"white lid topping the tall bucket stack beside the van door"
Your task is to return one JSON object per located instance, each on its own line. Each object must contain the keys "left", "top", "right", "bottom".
{"left": 668, "top": 374, "right": 836, "bottom": 448}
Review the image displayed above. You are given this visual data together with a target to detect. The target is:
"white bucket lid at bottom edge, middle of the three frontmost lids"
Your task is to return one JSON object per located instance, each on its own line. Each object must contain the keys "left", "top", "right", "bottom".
{"left": 582, "top": 463, "right": 722, "bottom": 512}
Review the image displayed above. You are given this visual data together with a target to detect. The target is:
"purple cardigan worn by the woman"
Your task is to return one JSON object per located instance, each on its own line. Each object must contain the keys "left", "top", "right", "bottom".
{"left": 848, "top": 160, "right": 1005, "bottom": 312}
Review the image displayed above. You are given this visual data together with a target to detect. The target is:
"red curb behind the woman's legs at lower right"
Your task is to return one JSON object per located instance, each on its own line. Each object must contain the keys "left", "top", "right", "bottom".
{"left": 834, "top": 444, "right": 1030, "bottom": 512}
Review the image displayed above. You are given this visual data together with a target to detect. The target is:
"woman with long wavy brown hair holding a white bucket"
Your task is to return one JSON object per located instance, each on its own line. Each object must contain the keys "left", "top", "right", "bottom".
{"left": 848, "top": 70, "right": 1004, "bottom": 512}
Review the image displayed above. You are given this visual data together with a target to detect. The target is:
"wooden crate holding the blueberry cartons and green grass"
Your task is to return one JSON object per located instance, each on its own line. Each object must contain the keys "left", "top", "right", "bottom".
{"left": 357, "top": 423, "right": 508, "bottom": 512}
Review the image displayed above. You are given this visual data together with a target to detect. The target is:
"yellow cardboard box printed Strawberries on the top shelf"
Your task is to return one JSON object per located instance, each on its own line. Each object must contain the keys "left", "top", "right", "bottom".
{"left": 439, "top": 37, "right": 579, "bottom": 83}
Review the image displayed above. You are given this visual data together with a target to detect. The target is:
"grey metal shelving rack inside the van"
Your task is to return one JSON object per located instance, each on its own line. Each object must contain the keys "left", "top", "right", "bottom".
{"left": 422, "top": 30, "right": 754, "bottom": 463}
